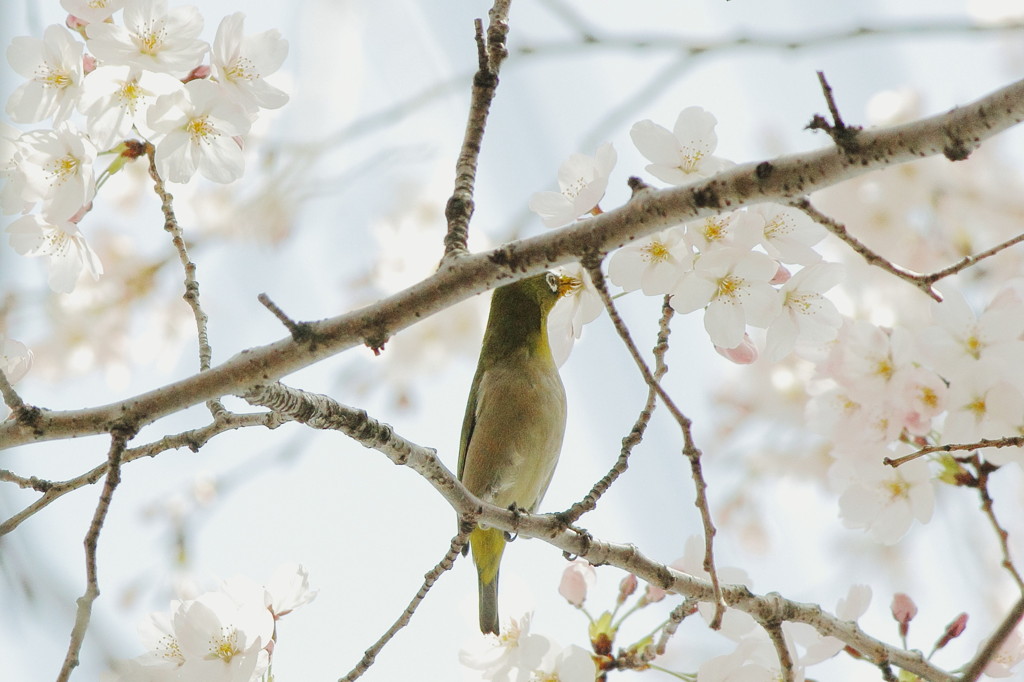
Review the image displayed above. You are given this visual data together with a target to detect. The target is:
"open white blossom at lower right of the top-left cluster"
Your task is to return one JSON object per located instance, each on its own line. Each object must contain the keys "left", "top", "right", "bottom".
{"left": 148, "top": 80, "right": 249, "bottom": 182}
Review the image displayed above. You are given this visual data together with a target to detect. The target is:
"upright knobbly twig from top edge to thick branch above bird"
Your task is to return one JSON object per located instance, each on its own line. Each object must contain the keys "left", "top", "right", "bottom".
{"left": 444, "top": 0, "right": 511, "bottom": 258}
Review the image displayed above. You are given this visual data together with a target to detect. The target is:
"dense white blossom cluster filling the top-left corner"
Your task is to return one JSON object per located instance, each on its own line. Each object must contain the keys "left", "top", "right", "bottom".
{"left": 0, "top": 0, "right": 288, "bottom": 293}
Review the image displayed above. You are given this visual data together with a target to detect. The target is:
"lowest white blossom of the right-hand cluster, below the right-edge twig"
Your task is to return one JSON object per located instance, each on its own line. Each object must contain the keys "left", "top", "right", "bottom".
{"left": 828, "top": 446, "right": 935, "bottom": 545}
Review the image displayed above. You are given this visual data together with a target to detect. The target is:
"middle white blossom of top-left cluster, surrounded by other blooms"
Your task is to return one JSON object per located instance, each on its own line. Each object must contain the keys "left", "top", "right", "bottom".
{"left": 79, "top": 66, "right": 183, "bottom": 150}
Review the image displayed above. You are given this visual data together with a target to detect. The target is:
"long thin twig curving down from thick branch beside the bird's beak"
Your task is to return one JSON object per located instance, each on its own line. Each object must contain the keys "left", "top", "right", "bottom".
{"left": 583, "top": 258, "right": 726, "bottom": 630}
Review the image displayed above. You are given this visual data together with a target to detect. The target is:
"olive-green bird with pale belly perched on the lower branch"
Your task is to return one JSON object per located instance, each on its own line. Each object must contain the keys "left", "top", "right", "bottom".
{"left": 459, "top": 272, "right": 565, "bottom": 635}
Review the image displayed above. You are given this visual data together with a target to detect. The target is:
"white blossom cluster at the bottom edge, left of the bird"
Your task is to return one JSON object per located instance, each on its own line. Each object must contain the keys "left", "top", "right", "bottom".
{"left": 104, "top": 564, "right": 316, "bottom": 682}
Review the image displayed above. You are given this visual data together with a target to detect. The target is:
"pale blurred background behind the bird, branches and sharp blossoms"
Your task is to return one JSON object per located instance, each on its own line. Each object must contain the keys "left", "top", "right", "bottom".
{"left": 0, "top": 0, "right": 1024, "bottom": 682}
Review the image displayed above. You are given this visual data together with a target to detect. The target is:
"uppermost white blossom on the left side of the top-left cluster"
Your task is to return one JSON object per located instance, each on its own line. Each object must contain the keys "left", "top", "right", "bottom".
{"left": 7, "top": 24, "right": 82, "bottom": 125}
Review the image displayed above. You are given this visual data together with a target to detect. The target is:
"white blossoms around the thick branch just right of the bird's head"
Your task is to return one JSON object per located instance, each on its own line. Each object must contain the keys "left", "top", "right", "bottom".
{"left": 530, "top": 106, "right": 842, "bottom": 364}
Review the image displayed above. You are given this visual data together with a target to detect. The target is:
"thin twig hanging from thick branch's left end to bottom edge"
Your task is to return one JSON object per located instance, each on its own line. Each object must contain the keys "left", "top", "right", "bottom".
{"left": 57, "top": 431, "right": 131, "bottom": 682}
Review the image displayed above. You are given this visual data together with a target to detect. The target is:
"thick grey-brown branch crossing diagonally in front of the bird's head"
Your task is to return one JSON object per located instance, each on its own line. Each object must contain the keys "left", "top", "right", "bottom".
{"left": 6, "top": 76, "right": 1024, "bottom": 449}
